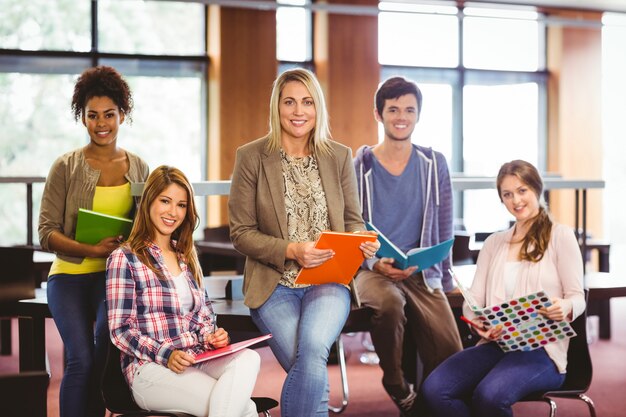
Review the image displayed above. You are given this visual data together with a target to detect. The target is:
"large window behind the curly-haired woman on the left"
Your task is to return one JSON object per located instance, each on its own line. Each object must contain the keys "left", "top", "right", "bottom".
{"left": 0, "top": 0, "right": 208, "bottom": 245}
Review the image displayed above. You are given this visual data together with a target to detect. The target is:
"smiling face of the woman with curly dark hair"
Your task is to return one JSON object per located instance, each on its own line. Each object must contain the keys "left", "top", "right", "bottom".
{"left": 83, "top": 97, "right": 124, "bottom": 146}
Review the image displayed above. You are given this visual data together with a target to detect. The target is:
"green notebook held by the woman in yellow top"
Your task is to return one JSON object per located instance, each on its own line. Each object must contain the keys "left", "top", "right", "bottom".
{"left": 76, "top": 208, "right": 133, "bottom": 245}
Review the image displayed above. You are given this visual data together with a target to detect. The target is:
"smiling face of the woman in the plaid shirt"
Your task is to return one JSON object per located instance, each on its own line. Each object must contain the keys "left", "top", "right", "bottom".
{"left": 150, "top": 184, "right": 188, "bottom": 242}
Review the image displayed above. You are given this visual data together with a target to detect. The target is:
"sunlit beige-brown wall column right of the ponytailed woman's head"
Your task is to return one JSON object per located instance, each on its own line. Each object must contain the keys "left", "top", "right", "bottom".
{"left": 547, "top": 12, "right": 602, "bottom": 238}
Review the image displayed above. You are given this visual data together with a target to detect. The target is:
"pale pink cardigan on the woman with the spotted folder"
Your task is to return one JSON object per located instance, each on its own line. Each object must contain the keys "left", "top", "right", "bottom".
{"left": 463, "top": 224, "right": 585, "bottom": 373}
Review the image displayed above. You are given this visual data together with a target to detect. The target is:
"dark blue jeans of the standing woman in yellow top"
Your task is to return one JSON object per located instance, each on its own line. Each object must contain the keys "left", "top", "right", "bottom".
{"left": 47, "top": 271, "right": 109, "bottom": 417}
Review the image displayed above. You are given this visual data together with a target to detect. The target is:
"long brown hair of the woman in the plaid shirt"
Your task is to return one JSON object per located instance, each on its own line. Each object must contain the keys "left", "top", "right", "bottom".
{"left": 126, "top": 165, "right": 202, "bottom": 286}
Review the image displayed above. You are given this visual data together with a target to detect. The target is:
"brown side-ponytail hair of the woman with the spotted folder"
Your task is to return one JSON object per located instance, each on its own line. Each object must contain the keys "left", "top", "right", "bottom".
{"left": 496, "top": 159, "right": 553, "bottom": 262}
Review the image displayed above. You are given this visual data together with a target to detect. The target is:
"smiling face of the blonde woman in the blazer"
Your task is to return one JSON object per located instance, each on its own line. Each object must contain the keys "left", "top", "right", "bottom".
{"left": 278, "top": 81, "right": 317, "bottom": 142}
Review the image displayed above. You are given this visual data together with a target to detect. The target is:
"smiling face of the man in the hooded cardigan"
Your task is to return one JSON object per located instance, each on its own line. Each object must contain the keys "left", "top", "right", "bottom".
{"left": 374, "top": 94, "right": 419, "bottom": 141}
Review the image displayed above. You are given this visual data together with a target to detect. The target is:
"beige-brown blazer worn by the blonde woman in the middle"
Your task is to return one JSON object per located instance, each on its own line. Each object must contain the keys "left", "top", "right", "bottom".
{"left": 228, "top": 138, "right": 365, "bottom": 308}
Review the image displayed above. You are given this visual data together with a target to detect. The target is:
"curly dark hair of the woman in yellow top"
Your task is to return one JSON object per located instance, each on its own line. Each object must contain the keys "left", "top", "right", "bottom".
{"left": 72, "top": 65, "right": 133, "bottom": 121}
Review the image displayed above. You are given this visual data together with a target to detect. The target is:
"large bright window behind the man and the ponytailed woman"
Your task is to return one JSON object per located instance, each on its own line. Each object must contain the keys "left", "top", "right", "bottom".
{"left": 379, "top": 2, "right": 547, "bottom": 232}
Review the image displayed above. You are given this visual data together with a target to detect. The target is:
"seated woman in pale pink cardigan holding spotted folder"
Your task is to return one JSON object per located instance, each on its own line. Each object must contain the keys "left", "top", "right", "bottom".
{"left": 422, "top": 160, "right": 585, "bottom": 417}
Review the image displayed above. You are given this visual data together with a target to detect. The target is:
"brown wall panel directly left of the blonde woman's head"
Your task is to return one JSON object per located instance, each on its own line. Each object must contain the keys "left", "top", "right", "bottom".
{"left": 207, "top": 6, "right": 278, "bottom": 226}
